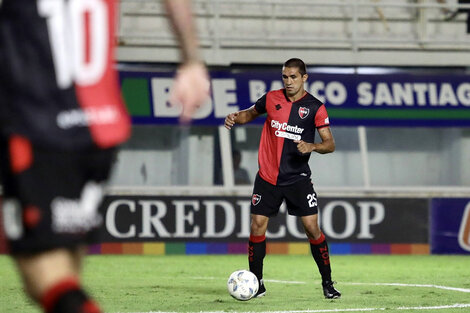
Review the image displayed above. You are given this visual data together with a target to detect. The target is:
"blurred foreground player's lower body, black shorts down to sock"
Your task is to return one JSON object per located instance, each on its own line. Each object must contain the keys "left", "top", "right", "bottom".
{"left": 2, "top": 140, "right": 113, "bottom": 313}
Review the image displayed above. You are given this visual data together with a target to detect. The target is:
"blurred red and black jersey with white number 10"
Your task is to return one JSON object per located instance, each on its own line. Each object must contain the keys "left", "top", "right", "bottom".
{"left": 0, "top": 0, "right": 130, "bottom": 149}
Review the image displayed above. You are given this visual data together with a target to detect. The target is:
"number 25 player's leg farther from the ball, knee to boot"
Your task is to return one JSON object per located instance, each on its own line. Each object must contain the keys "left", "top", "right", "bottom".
{"left": 301, "top": 214, "right": 341, "bottom": 299}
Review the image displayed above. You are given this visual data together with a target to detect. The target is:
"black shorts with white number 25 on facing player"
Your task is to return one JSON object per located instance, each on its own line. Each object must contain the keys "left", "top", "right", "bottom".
{"left": 251, "top": 174, "right": 318, "bottom": 217}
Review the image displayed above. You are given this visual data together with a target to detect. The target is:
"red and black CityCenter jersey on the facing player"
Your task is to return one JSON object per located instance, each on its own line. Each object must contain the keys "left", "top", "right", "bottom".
{"left": 255, "top": 89, "right": 329, "bottom": 186}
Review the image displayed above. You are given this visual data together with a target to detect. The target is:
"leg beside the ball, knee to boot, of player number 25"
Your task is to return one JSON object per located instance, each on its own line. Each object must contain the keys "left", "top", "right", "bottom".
{"left": 248, "top": 214, "right": 269, "bottom": 297}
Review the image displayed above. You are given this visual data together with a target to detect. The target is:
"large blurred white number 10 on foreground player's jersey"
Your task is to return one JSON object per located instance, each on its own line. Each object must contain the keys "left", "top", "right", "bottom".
{"left": 38, "top": 0, "right": 109, "bottom": 89}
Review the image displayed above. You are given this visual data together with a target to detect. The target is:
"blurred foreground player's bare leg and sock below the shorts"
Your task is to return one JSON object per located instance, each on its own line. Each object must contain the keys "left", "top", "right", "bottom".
{"left": 14, "top": 248, "right": 101, "bottom": 313}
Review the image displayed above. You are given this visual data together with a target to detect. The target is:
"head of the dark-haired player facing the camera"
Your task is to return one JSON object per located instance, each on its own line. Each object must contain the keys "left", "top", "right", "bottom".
{"left": 282, "top": 58, "right": 308, "bottom": 97}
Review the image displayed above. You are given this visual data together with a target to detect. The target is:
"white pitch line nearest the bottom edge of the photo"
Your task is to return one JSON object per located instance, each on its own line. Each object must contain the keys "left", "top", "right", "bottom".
{"left": 126, "top": 303, "right": 470, "bottom": 313}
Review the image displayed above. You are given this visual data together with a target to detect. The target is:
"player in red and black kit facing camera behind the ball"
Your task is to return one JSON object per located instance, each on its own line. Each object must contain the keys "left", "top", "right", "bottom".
{"left": 225, "top": 58, "right": 341, "bottom": 299}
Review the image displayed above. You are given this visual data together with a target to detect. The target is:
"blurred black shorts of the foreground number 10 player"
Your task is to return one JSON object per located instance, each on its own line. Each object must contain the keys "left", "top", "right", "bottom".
{"left": 0, "top": 141, "right": 115, "bottom": 254}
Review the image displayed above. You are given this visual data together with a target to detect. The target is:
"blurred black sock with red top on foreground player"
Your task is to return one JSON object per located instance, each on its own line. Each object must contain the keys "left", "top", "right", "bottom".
{"left": 41, "top": 278, "right": 101, "bottom": 313}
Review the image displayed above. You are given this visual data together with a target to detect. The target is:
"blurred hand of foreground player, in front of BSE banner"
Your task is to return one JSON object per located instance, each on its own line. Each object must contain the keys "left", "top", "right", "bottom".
{"left": 170, "top": 63, "right": 210, "bottom": 123}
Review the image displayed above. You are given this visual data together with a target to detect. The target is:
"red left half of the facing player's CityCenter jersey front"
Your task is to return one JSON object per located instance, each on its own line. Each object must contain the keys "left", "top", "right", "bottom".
{"left": 258, "top": 89, "right": 292, "bottom": 185}
